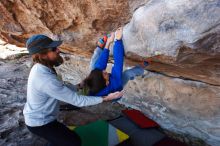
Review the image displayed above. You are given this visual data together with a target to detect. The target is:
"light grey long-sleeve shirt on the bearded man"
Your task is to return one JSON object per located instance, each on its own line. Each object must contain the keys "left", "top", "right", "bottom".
{"left": 23, "top": 63, "right": 103, "bottom": 127}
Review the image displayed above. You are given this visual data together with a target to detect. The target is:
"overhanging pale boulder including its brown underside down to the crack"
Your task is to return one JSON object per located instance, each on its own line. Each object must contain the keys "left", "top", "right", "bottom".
{"left": 123, "top": 0, "right": 220, "bottom": 86}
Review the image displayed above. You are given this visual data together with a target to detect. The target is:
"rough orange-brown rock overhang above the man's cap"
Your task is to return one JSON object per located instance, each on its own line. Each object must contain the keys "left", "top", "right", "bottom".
{"left": 0, "top": 0, "right": 138, "bottom": 55}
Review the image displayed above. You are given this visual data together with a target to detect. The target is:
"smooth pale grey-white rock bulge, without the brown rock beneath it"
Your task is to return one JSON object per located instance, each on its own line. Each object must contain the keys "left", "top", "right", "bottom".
{"left": 124, "top": 0, "right": 220, "bottom": 57}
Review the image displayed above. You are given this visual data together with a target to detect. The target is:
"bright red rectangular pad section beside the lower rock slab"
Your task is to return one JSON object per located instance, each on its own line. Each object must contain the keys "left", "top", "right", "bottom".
{"left": 122, "top": 109, "right": 160, "bottom": 128}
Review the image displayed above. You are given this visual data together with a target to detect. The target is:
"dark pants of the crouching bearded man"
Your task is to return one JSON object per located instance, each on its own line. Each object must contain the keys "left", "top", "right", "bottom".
{"left": 27, "top": 121, "right": 81, "bottom": 146}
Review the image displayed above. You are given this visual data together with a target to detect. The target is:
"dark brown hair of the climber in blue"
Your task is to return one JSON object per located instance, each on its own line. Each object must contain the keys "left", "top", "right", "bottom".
{"left": 84, "top": 69, "right": 106, "bottom": 95}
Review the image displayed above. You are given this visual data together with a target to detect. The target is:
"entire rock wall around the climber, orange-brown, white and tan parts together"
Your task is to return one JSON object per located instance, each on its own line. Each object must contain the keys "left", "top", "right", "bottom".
{"left": 0, "top": 0, "right": 220, "bottom": 146}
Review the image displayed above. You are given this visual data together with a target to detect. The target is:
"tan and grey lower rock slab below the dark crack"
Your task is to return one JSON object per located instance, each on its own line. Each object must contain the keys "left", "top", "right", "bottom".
{"left": 121, "top": 72, "right": 220, "bottom": 146}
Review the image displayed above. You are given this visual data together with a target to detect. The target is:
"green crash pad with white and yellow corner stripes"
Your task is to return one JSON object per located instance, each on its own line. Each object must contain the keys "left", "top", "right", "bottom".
{"left": 69, "top": 120, "right": 129, "bottom": 146}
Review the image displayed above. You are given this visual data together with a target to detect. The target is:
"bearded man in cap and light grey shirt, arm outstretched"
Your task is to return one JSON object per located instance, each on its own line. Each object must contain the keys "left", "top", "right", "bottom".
{"left": 23, "top": 34, "right": 122, "bottom": 146}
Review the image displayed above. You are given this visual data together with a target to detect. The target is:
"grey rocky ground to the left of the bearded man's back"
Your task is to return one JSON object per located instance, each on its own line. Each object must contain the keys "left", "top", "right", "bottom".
{"left": 0, "top": 57, "right": 35, "bottom": 145}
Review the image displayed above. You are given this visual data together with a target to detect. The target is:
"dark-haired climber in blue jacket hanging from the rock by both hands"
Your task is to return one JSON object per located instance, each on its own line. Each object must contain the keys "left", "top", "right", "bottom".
{"left": 83, "top": 28, "right": 144, "bottom": 96}
